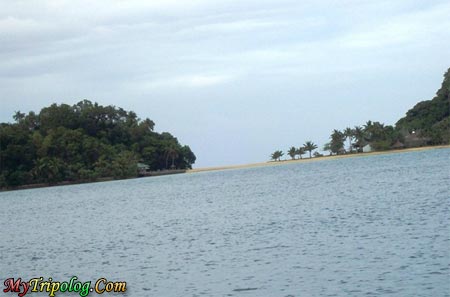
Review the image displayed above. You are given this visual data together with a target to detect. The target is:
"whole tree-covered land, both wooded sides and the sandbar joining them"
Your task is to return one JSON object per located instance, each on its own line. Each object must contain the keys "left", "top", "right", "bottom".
{"left": 0, "top": 68, "right": 450, "bottom": 189}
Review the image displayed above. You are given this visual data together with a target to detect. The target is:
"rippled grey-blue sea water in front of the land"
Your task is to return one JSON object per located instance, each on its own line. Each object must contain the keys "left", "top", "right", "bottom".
{"left": 0, "top": 149, "right": 450, "bottom": 296}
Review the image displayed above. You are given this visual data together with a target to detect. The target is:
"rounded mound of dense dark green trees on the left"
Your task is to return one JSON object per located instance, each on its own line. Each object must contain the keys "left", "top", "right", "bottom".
{"left": 0, "top": 100, "right": 196, "bottom": 187}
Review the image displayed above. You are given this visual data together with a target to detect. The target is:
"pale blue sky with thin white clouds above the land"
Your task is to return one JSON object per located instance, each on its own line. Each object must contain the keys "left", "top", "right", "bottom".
{"left": 0, "top": 0, "right": 450, "bottom": 167}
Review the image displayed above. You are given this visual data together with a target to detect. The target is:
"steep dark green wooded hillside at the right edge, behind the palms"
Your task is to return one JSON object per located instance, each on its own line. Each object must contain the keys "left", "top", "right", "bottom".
{"left": 396, "top": 68, "right": 450, "bottom": 144}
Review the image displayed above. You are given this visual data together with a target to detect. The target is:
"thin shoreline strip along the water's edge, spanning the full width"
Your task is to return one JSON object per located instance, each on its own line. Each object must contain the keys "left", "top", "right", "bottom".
{"left": 0, "top": 144, "right": 450, "bottom": 193}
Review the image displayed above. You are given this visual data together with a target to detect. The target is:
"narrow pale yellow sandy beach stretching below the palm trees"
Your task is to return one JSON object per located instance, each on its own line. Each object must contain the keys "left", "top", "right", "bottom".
{"left": 186, "top": 145, "right": 450, "bottom": 173}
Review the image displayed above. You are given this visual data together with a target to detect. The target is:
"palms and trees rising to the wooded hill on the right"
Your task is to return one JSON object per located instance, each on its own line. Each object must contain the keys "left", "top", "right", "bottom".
{"left": 271, "top": 68, "right": 450, "bottom": 161}
